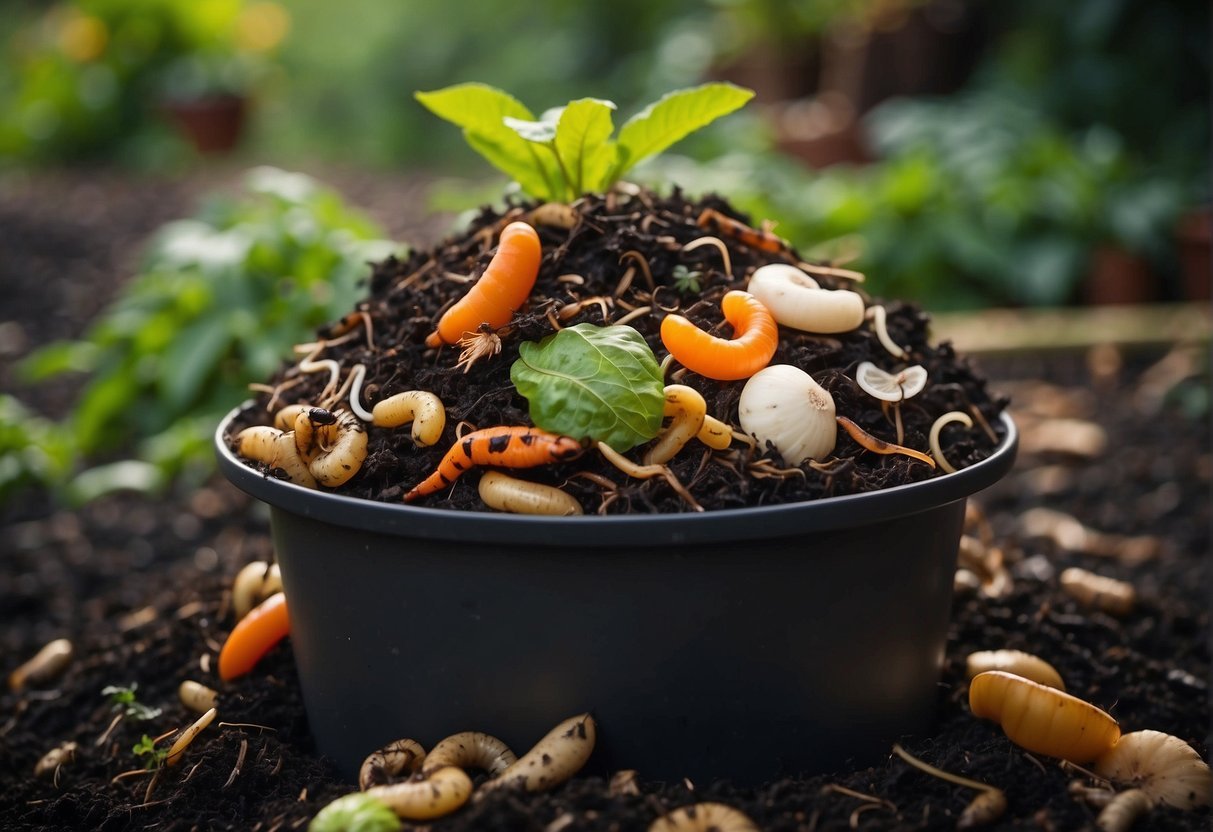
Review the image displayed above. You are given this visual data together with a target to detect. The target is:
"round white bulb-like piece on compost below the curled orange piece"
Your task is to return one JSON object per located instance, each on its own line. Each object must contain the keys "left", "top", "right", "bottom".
{"left": 738, "top": 364, "right": 838, "bottom": 466}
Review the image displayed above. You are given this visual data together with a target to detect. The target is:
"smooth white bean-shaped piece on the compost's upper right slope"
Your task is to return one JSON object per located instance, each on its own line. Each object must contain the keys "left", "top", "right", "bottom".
{"left": 746, "top": 263, "right": 864, "bottom": 335}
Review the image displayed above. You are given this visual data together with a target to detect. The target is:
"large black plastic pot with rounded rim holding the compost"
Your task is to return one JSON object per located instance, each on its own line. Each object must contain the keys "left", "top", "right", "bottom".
{"left": 216, "top": 412, "right": 1016, "bottom": 782}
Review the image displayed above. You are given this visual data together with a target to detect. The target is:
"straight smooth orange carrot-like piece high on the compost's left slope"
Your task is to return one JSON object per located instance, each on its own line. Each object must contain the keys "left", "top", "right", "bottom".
{"left": 426, "top": 222, "right": 542, "bottom": 347}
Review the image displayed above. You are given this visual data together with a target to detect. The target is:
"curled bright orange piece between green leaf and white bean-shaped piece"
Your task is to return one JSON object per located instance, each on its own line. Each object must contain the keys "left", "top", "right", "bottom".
{"left": 661, "top": 290, "right": 779, "bottom": 381}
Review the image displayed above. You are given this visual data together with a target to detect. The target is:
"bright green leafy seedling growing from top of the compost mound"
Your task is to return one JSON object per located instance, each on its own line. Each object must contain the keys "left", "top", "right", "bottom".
{"left": 416, "top": 82, "right": 753, "bottom": 203}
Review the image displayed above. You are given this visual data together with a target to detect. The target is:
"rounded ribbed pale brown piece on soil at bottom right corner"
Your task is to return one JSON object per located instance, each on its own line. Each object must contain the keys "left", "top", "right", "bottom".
{"left": 1094, "top": 730, "right": 1213, "bottom": 810}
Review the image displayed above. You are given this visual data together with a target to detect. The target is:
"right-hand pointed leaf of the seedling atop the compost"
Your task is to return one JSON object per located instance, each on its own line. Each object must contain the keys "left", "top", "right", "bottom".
{"left": 613, "top": 82, "right": 754, "bottom": 178}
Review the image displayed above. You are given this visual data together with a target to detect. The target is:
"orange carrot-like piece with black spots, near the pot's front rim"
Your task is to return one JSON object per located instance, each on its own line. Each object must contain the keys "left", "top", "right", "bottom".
{"left": 404, "top": 424, "right": 582, "bottom": 502}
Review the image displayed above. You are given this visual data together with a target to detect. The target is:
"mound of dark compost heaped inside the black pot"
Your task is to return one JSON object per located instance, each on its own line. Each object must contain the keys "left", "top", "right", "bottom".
{"left": 225, "top": 190, "right": 1006, "bottom": 513}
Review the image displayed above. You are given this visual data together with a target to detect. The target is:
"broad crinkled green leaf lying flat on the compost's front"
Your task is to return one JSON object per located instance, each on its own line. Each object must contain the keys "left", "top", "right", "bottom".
{"left": 509, "top": 324, "right": 665, "bottom": 451}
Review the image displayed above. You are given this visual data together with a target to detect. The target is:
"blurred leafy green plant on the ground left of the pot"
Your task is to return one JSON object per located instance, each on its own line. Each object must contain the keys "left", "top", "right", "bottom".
{"left": 10, "top": 167, "right": 398, "bottom": 500}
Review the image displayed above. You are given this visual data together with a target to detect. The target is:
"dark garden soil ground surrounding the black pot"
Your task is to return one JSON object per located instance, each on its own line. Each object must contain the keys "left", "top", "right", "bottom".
{"left": 0, "top": 166, "right": 1213, "bottom": 832}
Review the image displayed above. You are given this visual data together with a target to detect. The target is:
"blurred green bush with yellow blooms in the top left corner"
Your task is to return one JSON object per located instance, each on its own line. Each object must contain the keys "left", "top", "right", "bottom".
{"left": 0, "top": 0, "right": 290, "bottom": 161}
